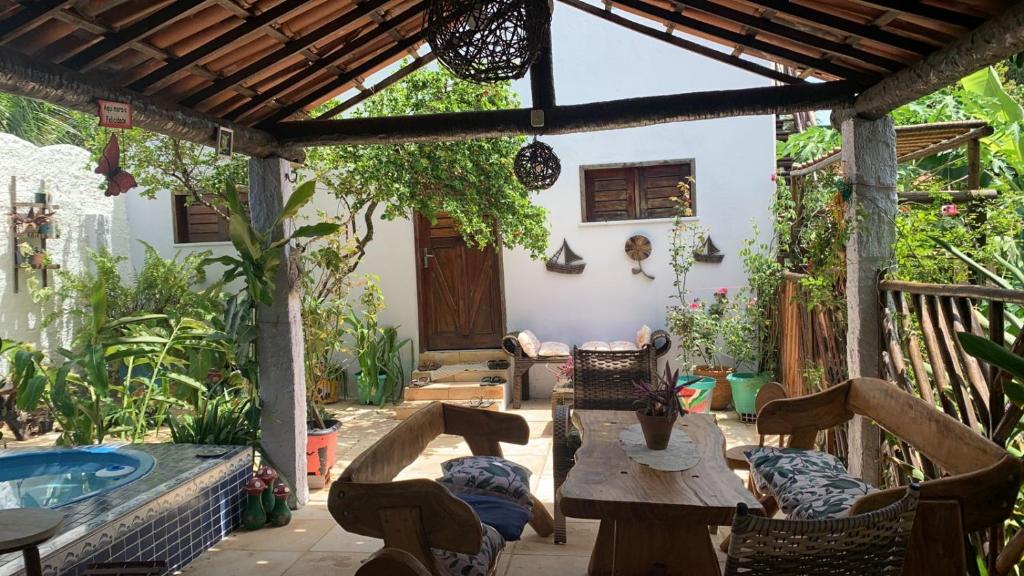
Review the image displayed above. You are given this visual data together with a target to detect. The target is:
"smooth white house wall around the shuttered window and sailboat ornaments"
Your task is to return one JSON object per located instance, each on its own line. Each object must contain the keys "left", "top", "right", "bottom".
{"left": 119, "top": 5, "right": 774, "bottom": 395}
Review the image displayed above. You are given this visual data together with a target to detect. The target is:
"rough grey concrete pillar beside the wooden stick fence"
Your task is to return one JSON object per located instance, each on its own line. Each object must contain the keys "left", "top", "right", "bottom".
{"left": 841, "top": 112, "right": 897, "bottom": 486}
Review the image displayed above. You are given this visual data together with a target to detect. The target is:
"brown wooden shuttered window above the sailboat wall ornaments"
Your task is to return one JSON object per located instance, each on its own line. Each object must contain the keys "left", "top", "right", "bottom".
{"left": 583, "top": 161, "right": 696, "bottom": 222}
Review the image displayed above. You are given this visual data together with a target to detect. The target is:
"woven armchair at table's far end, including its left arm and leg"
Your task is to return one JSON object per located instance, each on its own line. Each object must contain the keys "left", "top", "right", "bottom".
{"left": 552, "top": 345, "right": 658, "bottom": 544}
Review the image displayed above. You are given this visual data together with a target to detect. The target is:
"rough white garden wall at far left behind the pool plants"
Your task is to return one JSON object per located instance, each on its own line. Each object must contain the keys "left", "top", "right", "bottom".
{"left": 0, "top": 134, "right": 129, "bottom": 351}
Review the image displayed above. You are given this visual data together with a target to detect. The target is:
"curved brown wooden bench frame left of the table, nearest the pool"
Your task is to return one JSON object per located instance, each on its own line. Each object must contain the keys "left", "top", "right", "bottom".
{"left": 328, "top": 402, "right": 554, "bottom": 576}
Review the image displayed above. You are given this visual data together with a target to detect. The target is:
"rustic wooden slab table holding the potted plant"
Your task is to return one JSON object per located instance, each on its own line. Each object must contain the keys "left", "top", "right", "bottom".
{"left": 560, "top": 410, "right": 762, "bottom": 576}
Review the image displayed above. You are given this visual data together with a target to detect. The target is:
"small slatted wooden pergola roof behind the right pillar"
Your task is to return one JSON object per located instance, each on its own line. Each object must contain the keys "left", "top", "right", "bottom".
{"left": 788, "top": 120, "right": 992, "bottom": 176}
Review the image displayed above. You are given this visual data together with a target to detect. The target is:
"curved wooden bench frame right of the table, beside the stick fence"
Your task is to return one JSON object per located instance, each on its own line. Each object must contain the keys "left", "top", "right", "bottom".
{"left": 758, "top": 378, "right": 1022, "bottom": 576}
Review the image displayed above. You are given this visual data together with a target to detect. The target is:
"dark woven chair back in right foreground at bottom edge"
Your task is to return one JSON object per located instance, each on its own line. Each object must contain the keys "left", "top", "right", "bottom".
{"left": 725, "top": 485, "right": 921, "bottom": 576}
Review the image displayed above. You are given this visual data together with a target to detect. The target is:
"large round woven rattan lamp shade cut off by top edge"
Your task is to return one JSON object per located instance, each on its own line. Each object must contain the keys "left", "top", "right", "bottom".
{"left": 427, "top": 0, "right": 551, "bottom": 83}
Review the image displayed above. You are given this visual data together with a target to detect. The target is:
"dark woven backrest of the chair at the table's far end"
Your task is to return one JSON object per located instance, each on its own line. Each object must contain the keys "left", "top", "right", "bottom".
{"left": 572, "top": 345, "right": 656, "bottom": 410}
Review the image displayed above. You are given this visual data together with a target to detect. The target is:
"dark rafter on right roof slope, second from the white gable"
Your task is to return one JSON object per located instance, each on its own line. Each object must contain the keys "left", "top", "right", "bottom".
{"left": 602, "top": 0, "right": 878, "bottom": 81}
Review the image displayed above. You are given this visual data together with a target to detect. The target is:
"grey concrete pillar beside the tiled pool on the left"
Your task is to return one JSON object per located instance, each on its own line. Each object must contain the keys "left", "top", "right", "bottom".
{"left": 249, "top": 157, "right": 309, "bottom": 505}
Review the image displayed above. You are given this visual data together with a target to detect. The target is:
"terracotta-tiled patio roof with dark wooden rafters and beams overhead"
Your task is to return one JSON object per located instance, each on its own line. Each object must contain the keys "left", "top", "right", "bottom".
{"left": 0, "top": 0, "right": 1024, "bottom": 155}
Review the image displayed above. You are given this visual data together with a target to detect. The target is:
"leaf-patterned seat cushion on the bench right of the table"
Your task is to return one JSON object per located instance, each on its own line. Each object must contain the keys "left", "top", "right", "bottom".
{"left": 745, "top": 446, "right": 877, "bottom": 520}
